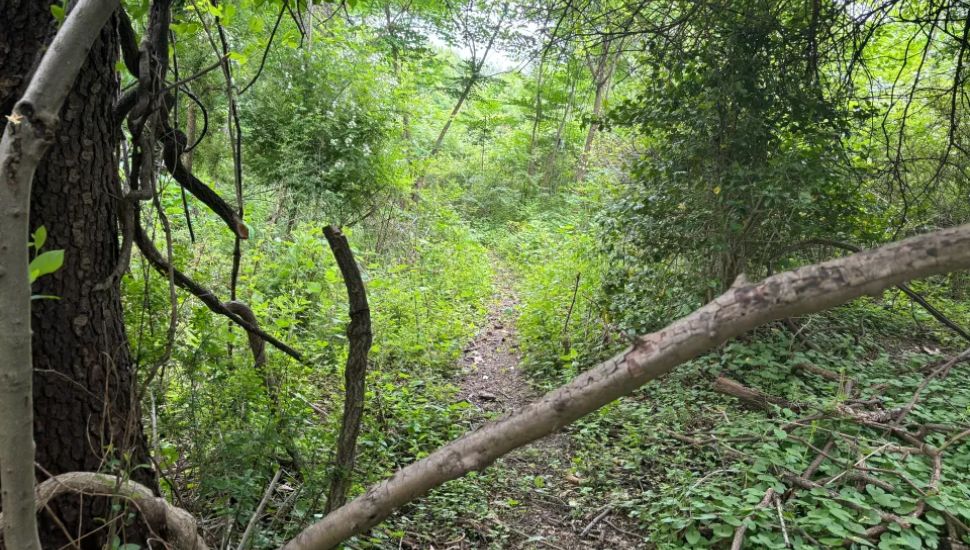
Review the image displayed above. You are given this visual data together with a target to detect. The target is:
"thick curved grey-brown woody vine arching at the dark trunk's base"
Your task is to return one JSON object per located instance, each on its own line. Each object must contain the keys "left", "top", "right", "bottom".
{"left": 0, "top": 472, "right": 208, "bottom": 550}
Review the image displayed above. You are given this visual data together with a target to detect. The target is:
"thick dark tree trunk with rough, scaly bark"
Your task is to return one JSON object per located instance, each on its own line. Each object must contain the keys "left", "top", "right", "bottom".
{"left": 0, "top": 0, "right": 156, "bottom": 548}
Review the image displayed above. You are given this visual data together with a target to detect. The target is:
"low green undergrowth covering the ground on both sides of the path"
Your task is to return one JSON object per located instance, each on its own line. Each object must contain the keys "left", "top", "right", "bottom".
{"left": 126, "top": 184, "right": 970, "bottom": 548}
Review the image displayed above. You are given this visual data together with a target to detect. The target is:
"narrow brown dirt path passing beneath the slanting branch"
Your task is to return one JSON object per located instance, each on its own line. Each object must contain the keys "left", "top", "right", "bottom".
{"left": 434, "top": 265, "right": 644, "bottom": 550}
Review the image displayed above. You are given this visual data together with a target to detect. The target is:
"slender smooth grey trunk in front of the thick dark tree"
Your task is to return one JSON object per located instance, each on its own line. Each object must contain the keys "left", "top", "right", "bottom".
{"left": 0, "top": 0, "right": 118, "bottom": 550}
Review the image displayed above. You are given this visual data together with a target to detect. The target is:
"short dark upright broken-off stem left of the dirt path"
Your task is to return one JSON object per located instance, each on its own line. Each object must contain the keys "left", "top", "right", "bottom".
{"left": 323, "top": 225, "right": 373, "bottom": 512}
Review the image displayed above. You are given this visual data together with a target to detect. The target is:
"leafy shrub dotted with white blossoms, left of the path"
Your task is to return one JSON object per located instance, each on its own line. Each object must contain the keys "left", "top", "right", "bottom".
{"left": 243, "top": 23, "right": 404, "bottom": 222}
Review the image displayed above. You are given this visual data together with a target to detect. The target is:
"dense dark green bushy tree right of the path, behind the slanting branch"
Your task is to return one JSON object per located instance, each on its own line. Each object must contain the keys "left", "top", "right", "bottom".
{"left": 605, "top": 2, "right": 881, "bottom": 298}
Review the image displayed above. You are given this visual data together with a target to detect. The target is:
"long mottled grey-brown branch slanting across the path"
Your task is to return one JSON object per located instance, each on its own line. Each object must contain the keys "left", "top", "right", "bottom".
{"left": 285, "top": 225, "right": 970, "bottom": 550}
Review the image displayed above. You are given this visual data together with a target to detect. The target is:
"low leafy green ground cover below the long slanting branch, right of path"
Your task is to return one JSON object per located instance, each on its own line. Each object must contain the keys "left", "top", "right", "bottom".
{"left": 552, "top": 312, "right": 970, "bottom": 548}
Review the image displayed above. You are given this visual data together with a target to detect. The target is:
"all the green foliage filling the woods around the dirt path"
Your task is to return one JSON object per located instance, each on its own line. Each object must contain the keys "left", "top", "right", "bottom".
{"left": 100, "top": 0, "right": 970, "bottom": 548}
